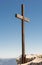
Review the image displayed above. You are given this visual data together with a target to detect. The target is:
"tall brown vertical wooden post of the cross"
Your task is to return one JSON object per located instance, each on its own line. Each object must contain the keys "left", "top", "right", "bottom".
{"left": 21, "top": 4, "right": 25, "bottom": 63}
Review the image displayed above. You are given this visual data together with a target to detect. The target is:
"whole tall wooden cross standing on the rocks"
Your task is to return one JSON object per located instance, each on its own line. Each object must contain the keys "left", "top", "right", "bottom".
{"left": 15, "top": 4, "right": 29, "bottom": 63}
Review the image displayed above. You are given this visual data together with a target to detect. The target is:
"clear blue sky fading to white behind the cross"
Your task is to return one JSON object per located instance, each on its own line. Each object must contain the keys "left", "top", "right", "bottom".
{"left": 0, "top": 0, "right": 42, "bottom": 58}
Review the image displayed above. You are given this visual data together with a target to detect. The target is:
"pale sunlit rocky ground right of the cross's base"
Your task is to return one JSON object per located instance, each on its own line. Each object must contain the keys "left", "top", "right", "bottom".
{"left": 16, "top": 54, "right": 42, "bottom": 65}
